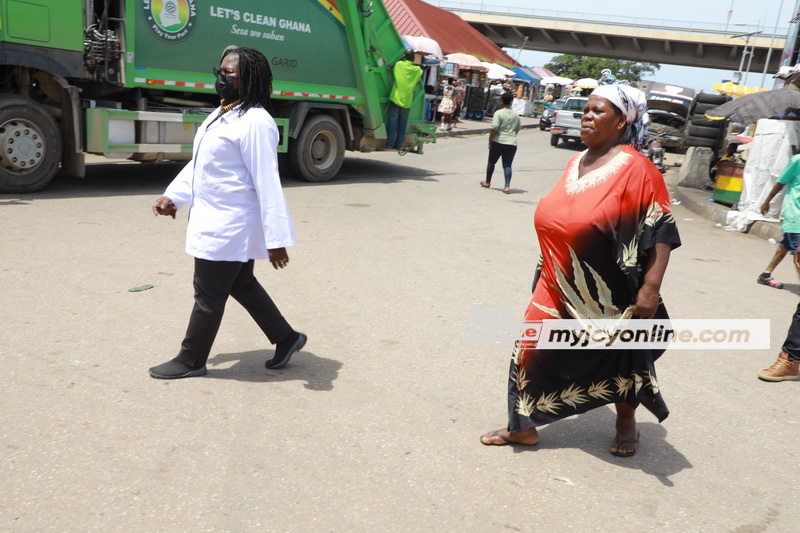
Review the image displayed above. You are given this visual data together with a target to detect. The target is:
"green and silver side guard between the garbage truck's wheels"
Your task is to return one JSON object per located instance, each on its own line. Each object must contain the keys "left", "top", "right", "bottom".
{"left": 86, "top": 107, "right": 289, "bottom": 157}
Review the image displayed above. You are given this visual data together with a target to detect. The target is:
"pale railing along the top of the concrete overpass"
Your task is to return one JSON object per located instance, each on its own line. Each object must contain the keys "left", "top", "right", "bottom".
{"left": 426, "top": 0, "right": 789, "bottom": 39}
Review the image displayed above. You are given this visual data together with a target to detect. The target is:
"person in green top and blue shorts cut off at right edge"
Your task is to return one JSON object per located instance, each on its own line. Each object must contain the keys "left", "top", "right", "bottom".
{"left": 756, "top": 154, "right": 800, "bottom": 289}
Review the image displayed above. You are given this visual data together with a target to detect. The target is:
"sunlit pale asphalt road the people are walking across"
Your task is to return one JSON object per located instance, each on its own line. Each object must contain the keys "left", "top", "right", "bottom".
{"left": 0, "top": 130, "right": 800, "bottom": 532}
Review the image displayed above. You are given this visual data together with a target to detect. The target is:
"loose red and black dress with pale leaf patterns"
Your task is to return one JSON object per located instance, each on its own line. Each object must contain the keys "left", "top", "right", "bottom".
{"left": 508, "top": 145, "right": 680, "bottom": 432}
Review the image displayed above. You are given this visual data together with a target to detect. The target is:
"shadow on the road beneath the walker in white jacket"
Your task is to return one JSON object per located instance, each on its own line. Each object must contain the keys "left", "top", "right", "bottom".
{"left": 206, "top": 350, "right": 343, "bottom": 391}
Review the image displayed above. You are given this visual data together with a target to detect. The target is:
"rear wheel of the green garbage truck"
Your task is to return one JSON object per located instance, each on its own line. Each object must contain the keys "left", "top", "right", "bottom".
{"left": 289, "top": 115, "right": 344, "bottom": 181}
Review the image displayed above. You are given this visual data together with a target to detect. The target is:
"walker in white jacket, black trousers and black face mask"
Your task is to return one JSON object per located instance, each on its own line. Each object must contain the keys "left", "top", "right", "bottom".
{"left": 150, "top": 47, "right": 307, "bottom": 379}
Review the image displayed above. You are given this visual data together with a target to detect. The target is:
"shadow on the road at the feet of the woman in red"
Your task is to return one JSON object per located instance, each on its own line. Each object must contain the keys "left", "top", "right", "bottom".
{"left": 514, "top": 407, "right": 693, "bottom": 487}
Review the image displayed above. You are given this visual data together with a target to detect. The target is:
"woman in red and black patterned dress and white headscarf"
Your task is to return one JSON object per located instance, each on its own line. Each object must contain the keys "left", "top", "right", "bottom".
{"left": 481, "top": 84, "right": 680, "bottom": 457}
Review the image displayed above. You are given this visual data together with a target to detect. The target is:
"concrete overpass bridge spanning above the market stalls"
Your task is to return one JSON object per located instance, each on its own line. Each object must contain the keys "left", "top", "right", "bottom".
{"left": 430, "top": 0, "right": 788, "bottom": 73}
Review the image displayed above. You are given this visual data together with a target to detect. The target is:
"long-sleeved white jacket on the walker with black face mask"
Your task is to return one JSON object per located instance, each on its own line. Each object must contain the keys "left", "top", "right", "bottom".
{"left": 164, "top": 107, "right": 295, "bottom": 262}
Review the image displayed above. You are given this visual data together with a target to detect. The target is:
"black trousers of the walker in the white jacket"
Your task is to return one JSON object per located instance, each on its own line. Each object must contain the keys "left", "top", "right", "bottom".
{"left": 178, "top": 258, "right": 294, "bottom": 369}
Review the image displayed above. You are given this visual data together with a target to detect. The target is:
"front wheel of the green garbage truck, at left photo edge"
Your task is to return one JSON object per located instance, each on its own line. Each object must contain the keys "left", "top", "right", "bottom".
{"left": 0, "top": 96, "right": 61, "bottom": 193}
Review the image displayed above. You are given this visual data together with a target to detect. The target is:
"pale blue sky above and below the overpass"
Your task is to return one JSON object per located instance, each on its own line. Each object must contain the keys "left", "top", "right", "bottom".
{"left": 425, "top": 0, "right": 800, "bottom": 92}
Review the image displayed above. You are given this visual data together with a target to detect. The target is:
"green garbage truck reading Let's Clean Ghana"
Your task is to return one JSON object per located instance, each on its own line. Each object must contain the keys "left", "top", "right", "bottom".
{"left": 0, "top": 0, "right": 435, "bottom": 193}
